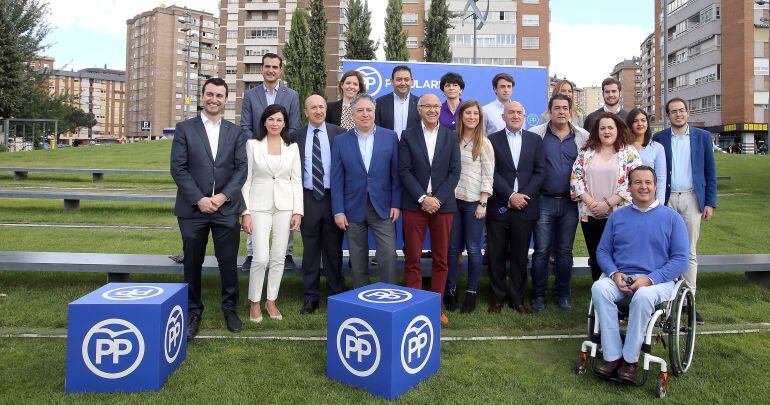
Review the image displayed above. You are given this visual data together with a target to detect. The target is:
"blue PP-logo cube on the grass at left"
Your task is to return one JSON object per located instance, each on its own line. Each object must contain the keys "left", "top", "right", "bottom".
{"left": 64, "top": 283, "right": 187, "bottom": 393}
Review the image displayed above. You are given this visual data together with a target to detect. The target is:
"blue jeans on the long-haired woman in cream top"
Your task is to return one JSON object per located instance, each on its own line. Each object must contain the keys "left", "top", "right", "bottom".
{"left": 446, "top": 200, "right": 484, "bottom": 293}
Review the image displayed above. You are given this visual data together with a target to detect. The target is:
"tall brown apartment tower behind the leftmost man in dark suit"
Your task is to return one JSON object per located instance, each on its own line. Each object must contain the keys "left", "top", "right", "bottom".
{"left": 126, "top": 6, "right": 219, "bottom": 139}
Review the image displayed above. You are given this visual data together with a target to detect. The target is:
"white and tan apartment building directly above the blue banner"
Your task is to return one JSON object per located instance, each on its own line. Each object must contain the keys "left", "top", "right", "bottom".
{"left": 401, "top": 0, "right": 551, "bottom": 66}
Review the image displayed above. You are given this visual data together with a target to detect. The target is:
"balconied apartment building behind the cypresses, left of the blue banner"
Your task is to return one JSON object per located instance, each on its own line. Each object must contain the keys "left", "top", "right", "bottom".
{"left": 219, "top": 0, "right": 347, "bottom": 122}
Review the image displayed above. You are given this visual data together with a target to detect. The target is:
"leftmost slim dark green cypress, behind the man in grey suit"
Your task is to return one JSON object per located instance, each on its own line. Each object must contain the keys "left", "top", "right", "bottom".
{"left": 283, "top": 8, "right": 313, "bottom": 112}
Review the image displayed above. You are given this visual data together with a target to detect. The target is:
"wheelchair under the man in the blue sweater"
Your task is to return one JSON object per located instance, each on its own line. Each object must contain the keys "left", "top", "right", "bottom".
{"left": 575, "top": 279, "right": 696, "bottom": 398}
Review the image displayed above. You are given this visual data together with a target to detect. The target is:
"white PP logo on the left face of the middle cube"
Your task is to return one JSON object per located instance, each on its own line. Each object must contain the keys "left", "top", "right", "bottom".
{"left": 337, "top": 318, "right": 380, "bottom": 377}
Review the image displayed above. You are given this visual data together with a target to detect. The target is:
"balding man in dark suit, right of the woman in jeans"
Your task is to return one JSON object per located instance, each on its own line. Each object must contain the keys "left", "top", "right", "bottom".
{"left": 487, "top": 101, "right": 546, "bottom": 314}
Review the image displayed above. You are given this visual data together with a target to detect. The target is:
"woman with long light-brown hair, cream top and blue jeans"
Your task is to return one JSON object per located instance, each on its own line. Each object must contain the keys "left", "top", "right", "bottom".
{"left": 444, "top": 100, "right": 495, "bottom": 313}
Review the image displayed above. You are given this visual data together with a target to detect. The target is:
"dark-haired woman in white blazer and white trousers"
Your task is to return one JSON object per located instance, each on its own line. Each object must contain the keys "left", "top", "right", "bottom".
{"left": 241, "top": 104, "right": 303, "bottom": 322}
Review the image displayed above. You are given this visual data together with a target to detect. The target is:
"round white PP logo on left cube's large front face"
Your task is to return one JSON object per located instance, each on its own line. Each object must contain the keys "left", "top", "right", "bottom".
{"left": 82, "top": 318, "right": 144, "bottom": 379}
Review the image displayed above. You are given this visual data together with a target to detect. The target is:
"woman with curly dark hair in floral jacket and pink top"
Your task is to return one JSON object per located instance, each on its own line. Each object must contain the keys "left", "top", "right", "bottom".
{"left": 570, "top": 112, "right": 642, "bottom": 281}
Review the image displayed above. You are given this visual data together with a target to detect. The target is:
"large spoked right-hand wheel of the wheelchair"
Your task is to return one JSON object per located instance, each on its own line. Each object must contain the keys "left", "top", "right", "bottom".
{"left": 668, "top": 285, "right": 696, "bottom": 376}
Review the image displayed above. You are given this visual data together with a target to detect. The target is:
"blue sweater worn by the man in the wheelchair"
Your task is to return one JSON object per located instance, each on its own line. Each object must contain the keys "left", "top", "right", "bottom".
{"left": 596, "top": 204, "right": 690, "bottom": 284}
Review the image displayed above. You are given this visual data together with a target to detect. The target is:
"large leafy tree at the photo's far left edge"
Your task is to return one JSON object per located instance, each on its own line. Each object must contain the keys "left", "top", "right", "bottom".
{"left": 0, "top": 0, "right": 50, "bottom": 118}
